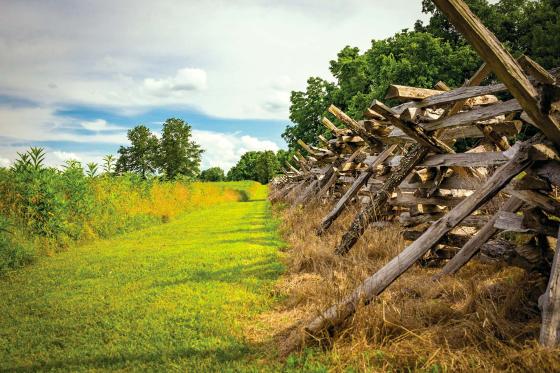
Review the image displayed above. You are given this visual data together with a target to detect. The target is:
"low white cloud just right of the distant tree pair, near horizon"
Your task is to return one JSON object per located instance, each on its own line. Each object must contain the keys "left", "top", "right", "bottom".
{"left": 193, "top": 130, "right": 279, "bottom": 171}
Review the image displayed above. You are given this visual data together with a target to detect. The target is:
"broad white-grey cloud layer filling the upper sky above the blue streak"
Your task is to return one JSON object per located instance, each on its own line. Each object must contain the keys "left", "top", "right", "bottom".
{"left": 0, "top": 0, "right": 422, "bottom": 119}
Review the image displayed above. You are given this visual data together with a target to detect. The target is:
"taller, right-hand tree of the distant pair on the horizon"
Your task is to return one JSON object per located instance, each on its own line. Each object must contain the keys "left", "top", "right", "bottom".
{"left": 158, "top": 118, "right": 203, "bottom": 179}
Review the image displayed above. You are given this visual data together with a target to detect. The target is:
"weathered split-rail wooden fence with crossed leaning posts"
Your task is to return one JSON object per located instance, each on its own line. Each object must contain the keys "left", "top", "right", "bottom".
{"left": 271, "top": 0, "right": 560, "bottom": 346}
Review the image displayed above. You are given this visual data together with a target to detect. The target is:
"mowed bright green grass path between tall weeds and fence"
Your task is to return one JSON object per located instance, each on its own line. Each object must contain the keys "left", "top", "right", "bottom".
{"left": 0, "top": 182, "right": 282, "bottom": 372}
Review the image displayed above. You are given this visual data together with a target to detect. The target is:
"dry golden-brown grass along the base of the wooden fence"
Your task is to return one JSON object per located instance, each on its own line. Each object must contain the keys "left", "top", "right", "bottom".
{"left": 263, "top": 202, "right": 560, "bottom": 372}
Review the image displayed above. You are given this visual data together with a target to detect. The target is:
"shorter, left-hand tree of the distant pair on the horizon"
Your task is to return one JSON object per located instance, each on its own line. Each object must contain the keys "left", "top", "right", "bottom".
{"left": 115, "top": 125, "right": 158, "bottom": 179}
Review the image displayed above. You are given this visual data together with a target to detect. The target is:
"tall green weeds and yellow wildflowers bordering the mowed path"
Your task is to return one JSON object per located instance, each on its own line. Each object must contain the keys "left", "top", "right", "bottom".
{"left": 0, "top": 148, "right": 258, "bottom": 274}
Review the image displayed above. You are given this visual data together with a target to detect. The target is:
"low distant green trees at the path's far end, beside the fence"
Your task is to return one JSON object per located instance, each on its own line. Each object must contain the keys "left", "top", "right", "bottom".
{"left": 227, "top": 150, "right": 280, "bottom": 184}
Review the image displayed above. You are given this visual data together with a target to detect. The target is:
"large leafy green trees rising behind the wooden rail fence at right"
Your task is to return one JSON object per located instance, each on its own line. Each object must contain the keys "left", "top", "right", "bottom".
{"left": 282, "top": 0, "right": 560, "bottom": 151}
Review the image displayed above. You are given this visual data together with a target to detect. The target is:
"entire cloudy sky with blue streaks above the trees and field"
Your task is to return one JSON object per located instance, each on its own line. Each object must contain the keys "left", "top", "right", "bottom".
{"left": 0, "top": 0, "right": 424, "bottom": 169}
